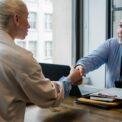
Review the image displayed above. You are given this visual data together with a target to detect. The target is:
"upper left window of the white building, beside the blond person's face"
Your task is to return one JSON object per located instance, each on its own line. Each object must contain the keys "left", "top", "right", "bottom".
{"left": 28, "top": 12, "right": 37, "bottom": 29}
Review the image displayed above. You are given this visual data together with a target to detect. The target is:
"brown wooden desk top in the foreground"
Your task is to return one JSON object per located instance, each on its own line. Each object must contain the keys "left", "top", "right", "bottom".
{"left": 24, "top": 97, "right": 122, "bottom": 122}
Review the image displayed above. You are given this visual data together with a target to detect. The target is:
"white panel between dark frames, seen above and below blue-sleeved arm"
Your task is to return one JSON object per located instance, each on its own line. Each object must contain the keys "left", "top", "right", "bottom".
{"left": 84, "top": 0, "right": 106, "bottom": 88}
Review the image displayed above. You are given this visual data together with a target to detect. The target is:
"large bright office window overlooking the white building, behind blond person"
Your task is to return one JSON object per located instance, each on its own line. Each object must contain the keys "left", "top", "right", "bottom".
{"left": 16, "top": 0, "right": 74, "bottom": 65}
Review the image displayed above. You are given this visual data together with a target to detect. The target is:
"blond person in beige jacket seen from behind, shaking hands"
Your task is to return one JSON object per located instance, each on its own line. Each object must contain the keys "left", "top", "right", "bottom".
{"left": 0, "top": 0, "right": 81, "bottom": 122}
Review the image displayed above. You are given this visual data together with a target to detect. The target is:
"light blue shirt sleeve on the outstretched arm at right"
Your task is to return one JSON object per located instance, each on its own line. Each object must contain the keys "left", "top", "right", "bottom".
{"left": 76, "top": 40, "right": 110, "bottom": 73}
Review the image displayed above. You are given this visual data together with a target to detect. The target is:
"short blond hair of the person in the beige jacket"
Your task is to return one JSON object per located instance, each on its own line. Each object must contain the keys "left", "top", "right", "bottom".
{"left": 0, "top": 0, "right": 26, "bottom": 29}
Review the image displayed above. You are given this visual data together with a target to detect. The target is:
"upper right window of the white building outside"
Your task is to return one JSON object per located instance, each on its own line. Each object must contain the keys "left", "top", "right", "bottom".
{"left": 45, "top": 13, "right": 52, "bottom": 31}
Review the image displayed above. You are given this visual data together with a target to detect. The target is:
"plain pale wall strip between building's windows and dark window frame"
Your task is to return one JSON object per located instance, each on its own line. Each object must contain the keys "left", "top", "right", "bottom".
{"left": 53, "top": 0, "right": 72, "bottom": 65}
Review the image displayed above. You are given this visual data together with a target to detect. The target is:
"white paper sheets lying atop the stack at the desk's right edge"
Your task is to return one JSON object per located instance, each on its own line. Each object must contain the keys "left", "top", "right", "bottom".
{"left": 90, "top": 88, "right": 122, "bottom": 100}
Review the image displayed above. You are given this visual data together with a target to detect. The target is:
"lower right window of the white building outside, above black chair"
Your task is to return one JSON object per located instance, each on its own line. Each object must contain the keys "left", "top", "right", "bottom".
{"left": 45, "top": 41, "right": 52, "bottom": 58}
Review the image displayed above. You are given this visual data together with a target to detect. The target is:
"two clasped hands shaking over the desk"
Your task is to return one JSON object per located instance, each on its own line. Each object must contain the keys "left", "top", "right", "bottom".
{"left": 68, "top": 65, "right": 85, "bottom": 85}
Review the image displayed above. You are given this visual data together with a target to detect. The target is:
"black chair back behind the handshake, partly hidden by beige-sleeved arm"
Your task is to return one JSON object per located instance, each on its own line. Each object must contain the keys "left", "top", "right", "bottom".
{"left": 39, "top": 63, "right": 81, "bottom": 97}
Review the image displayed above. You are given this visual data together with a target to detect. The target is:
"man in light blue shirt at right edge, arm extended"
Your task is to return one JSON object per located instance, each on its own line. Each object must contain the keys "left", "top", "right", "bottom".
{"left": 76, "top": 20, "right": 122, "bottom": 88}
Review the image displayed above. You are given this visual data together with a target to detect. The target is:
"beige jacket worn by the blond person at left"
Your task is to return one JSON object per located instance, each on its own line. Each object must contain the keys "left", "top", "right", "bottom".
{"left": 0, "top": 30, "right": 64, "bottom": 122}
